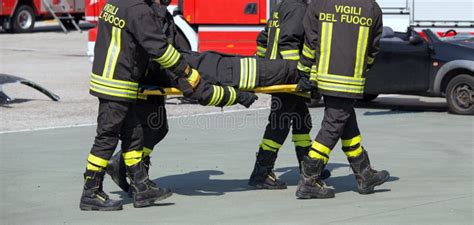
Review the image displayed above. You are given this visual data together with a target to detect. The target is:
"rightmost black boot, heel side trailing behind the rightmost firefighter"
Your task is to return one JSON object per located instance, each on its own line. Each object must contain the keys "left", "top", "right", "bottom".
{"left": 348, "top": 150, "right": 390, "bottom": 194}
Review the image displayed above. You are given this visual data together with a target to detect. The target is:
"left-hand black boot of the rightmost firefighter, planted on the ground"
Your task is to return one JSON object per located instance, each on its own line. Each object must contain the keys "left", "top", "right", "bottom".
{"left": 296, "top": 156, "right": 334, "bottom": 199}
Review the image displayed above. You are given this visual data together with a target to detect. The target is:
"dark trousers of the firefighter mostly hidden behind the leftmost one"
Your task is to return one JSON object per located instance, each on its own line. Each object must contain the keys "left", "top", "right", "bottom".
{"left": 135, "top": 96, "right": 169, "bottom": 156}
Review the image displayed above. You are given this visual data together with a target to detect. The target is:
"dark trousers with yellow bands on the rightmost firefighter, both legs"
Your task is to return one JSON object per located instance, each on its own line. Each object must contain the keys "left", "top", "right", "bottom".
{"left": 309, "top": 95, "right": 362, "bottom": 164}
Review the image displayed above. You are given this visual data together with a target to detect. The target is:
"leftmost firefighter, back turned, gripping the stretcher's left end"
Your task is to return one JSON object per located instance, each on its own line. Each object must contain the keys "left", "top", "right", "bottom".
{"left": 80, "top": 0, "right": 200, "bottom": 210}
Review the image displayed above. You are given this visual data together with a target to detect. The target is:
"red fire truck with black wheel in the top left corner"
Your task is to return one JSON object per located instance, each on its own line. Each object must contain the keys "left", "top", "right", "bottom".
{"left": 0, "top": 0, "right": 85, "bottom": 33}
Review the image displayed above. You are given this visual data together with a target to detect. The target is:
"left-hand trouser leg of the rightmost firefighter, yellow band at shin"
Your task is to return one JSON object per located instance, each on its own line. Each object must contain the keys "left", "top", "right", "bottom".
{"left": 309, "top": 95, "right": 358, "bottom": 164}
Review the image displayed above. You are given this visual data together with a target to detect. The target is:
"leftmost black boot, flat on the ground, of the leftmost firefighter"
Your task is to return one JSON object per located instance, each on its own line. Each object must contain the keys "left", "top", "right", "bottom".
{"left": 79, "top": 170, "right": 122, "bottom": 211}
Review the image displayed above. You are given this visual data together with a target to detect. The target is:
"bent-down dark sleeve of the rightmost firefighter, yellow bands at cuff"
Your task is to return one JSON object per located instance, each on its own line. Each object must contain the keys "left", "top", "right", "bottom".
{"left": 297, "top": 1, "right": 319, "bottom": 80}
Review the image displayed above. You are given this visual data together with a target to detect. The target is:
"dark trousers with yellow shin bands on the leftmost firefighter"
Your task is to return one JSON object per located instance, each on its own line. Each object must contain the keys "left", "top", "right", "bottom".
{"left": 87, "top": 98, "right": 143, "bottom": 170}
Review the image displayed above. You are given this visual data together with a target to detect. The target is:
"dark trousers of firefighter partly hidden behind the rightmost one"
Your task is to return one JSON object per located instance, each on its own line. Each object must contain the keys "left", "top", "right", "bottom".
{"left": 257, "top": 94, "right": 312, "bottom": 164}
